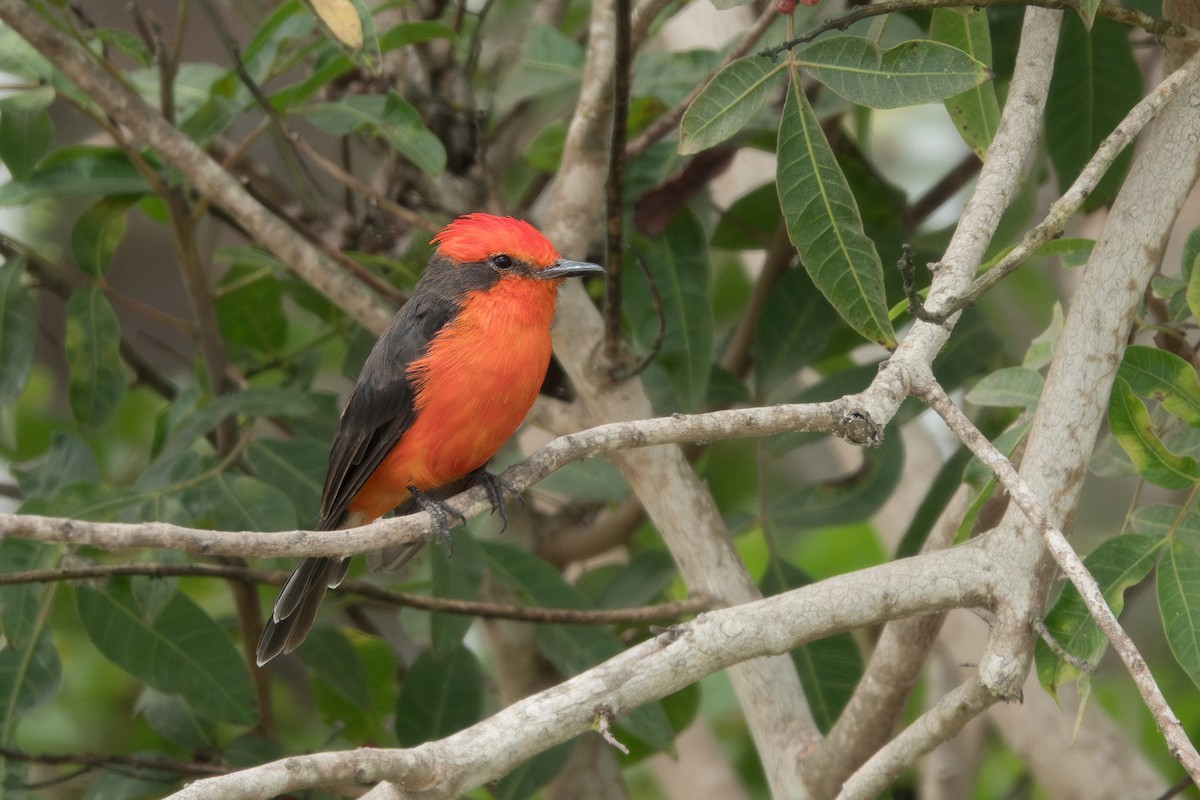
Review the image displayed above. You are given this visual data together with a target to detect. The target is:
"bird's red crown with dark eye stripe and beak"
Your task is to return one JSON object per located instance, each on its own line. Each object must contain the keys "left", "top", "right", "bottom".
{"left": 431, "top": 213, "right": 604, "bottom": 281}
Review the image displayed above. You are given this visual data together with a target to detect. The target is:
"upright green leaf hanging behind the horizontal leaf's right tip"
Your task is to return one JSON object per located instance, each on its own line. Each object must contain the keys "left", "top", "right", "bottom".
{"left": 929, "top": 8, "right": 1000, "bottom": 161}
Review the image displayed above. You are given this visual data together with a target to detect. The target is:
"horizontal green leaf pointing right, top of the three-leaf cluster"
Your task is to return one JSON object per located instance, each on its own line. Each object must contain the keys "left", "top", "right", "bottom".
{"left": 793, "top": 36, "right": 991, "bottom": 108}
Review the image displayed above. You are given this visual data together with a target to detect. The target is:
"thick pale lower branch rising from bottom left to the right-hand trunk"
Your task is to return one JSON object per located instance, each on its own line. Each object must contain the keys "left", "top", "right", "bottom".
{"left": 172, "top": 543, "right": 996, "bottom": 800}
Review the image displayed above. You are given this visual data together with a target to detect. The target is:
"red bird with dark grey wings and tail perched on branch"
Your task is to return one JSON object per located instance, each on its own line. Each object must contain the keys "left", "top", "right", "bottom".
{"left": 257, "top": 213, "right": 604, "bottom": 666}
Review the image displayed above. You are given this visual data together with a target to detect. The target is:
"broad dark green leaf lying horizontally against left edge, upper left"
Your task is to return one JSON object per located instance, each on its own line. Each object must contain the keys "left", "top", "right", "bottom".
{"left": 0, "top": 145, "right": 149, "bottom": 206}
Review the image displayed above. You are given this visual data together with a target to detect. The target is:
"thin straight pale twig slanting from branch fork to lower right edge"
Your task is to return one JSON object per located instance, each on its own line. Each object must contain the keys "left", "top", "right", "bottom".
{"left": 913, "top": 374, "right": 1200, "bottom": 782}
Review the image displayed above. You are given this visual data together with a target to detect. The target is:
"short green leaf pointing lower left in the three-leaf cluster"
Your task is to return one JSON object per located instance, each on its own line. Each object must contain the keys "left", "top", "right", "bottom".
{"left": 679, "top": 55, "right": 785, "bottom": 155}
